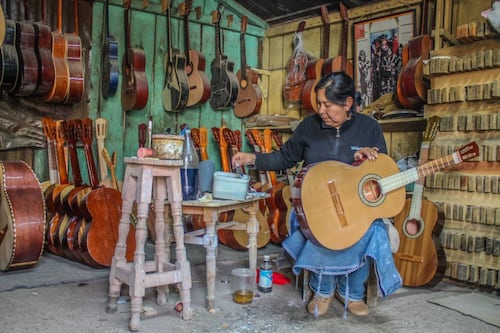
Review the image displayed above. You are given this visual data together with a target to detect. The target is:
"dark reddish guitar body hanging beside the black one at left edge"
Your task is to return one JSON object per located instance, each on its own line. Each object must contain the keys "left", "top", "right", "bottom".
{"left": 15, "top": 22, "right": 39, "bottom": 96}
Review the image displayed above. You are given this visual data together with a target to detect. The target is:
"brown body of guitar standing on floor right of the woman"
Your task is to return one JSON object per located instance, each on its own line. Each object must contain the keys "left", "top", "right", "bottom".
{"left": 394, "top": 198, "right": 446, "bottom": 287}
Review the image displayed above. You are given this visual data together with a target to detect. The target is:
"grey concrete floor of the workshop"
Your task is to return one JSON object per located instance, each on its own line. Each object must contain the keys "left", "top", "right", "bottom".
{"left": 0, "top": 241, "right": 500, "bottom": 333}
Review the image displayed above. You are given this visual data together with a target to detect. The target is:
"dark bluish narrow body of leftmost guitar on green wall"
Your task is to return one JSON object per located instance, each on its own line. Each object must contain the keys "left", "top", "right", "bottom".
{"left": 101, "top": 37, "right": 119, "bottom": 98}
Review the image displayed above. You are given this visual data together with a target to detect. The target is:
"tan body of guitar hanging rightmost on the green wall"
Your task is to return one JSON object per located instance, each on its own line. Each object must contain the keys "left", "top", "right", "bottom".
{"left": 233, "top": 66, "right": 262, "bottom": 118}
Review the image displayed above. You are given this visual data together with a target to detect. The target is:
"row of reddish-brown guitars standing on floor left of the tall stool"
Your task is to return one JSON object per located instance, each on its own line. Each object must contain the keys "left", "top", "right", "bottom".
{"left": 42, "top": 118, "right": 135, "bottom": 268}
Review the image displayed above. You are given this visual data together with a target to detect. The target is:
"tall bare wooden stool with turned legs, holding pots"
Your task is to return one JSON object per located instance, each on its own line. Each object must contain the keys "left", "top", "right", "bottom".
{"left": 107, "top": 157, "right": 192, "bottom": 331}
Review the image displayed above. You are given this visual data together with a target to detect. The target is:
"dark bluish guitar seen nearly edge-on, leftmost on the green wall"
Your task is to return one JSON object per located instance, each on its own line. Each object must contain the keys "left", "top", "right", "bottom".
{"left": 100, "top": 0, "right": 119, "bottom": 97}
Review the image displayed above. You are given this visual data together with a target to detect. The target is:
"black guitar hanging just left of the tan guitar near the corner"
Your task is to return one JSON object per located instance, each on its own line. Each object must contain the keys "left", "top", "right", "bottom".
{"left": 210, "top": 9, "right": 239, "bottom": 111}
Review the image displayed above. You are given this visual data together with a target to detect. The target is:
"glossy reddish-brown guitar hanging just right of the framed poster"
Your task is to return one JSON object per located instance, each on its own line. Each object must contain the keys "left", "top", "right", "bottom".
{"left": 396, "top": 1, "right": 432, "bottom": 111}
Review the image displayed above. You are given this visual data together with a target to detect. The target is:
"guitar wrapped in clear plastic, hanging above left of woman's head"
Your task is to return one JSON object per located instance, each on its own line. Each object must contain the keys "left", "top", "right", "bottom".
{"left": 283, "top": 21, "right": 309, "bottom": 104}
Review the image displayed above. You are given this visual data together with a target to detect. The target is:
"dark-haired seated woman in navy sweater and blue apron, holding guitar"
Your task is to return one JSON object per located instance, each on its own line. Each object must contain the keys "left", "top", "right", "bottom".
{"left": 232, "top": 72, "right": 402, "bottom": 316}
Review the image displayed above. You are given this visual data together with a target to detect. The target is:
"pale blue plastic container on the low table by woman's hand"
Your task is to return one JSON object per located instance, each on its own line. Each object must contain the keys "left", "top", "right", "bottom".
{"left": 212, "top": 171, "right": 250, "bottom": 201}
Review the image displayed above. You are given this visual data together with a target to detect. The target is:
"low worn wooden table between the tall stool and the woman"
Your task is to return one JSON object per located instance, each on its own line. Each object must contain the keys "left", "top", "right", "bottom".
{"left": 182, "top": 197, "right": 263, "bottom": 313}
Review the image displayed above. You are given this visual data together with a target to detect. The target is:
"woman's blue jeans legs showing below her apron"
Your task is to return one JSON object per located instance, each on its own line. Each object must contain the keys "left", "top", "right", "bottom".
{"left": 309, "top": 263, "right": 370, "bottom": 301}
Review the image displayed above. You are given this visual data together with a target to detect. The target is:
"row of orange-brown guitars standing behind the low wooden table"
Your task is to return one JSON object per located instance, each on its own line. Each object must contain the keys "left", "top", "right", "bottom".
{"left": 191, "top": 127, "right": 291, "bottom": 250}
